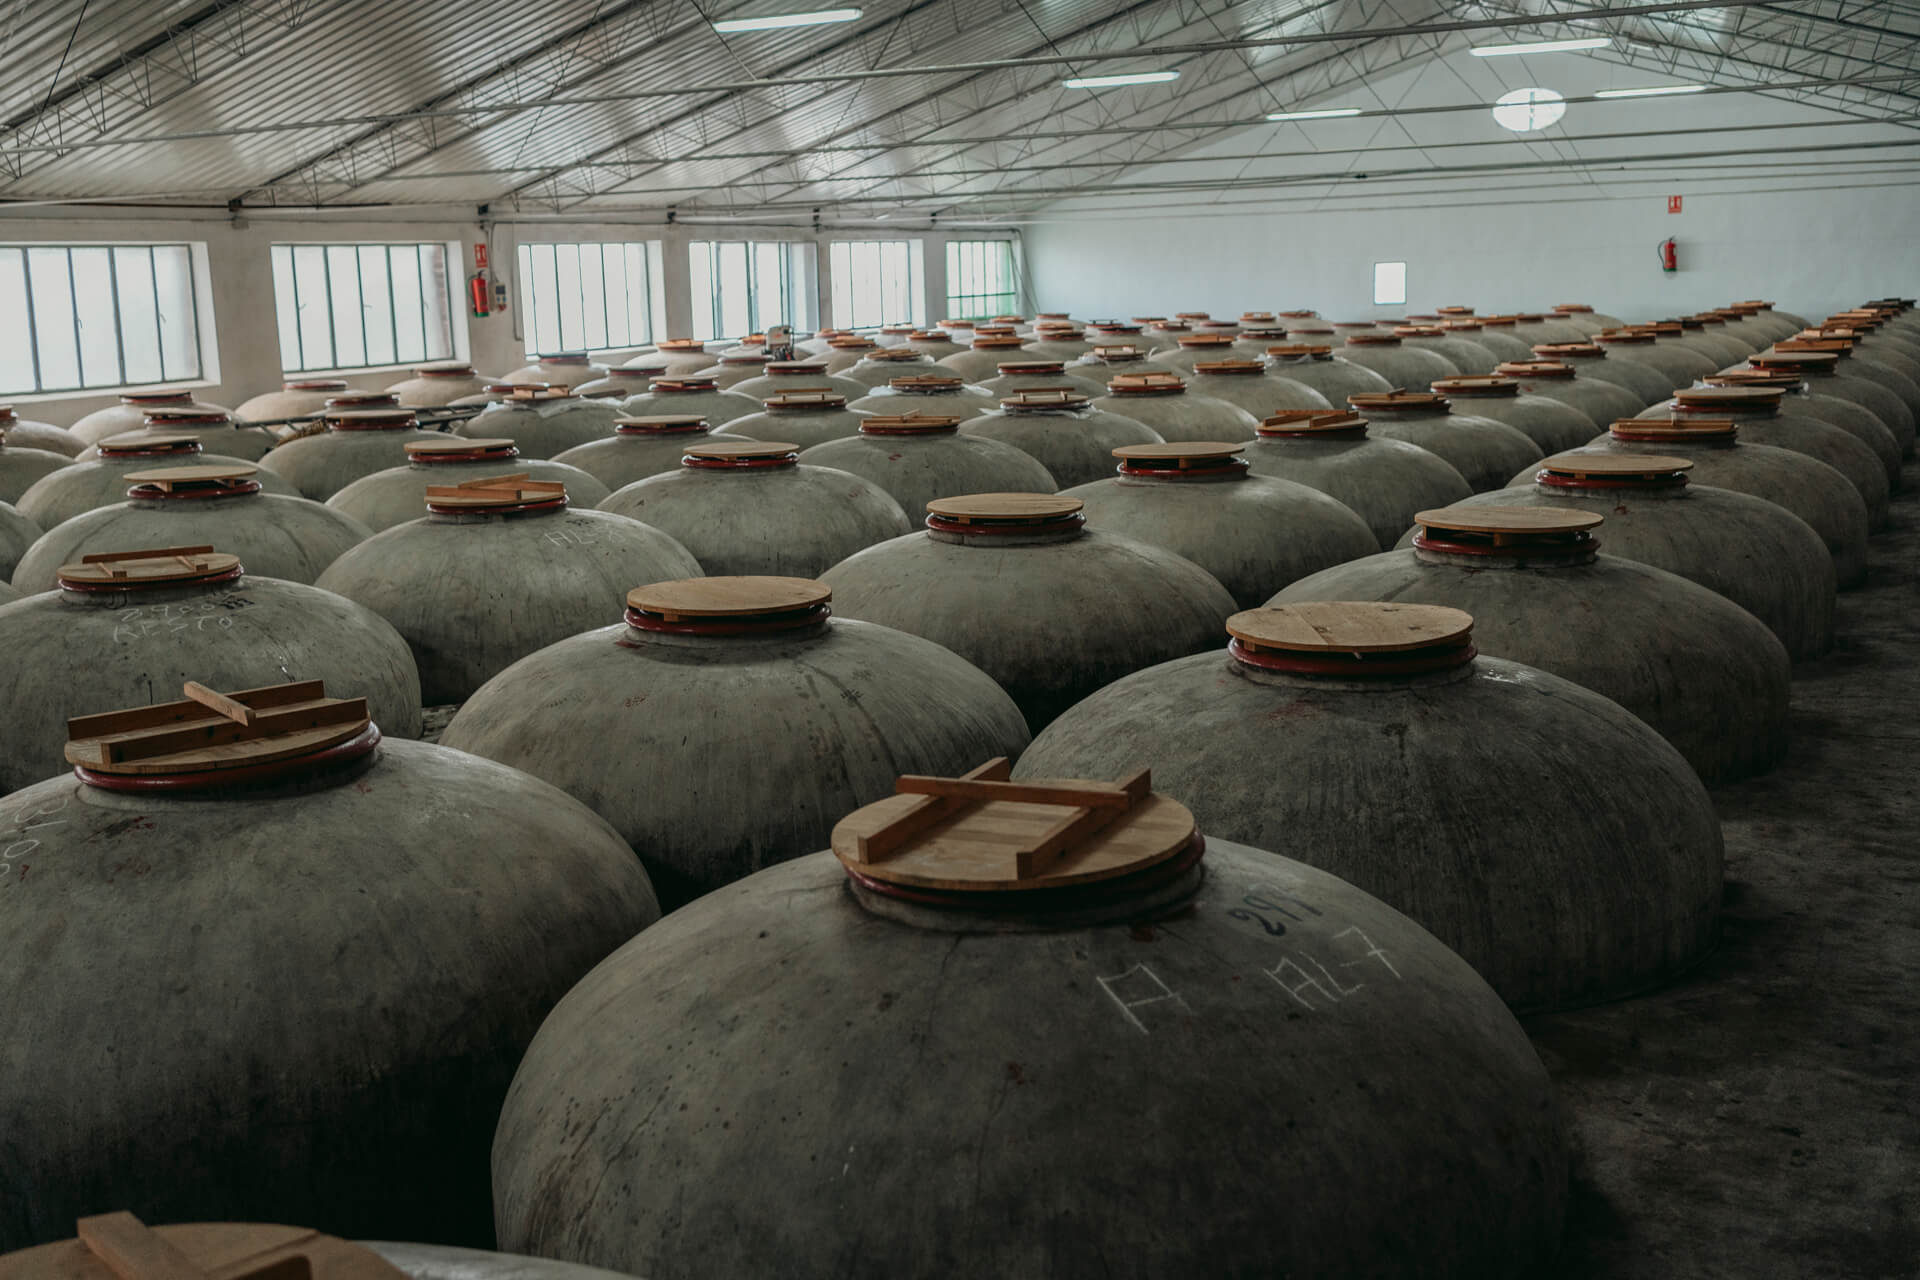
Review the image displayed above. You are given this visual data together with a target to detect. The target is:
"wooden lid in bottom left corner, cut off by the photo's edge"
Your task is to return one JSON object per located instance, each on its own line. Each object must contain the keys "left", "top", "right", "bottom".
{"left": 0, "top": 1213, "right": 407, "bottom": 1280}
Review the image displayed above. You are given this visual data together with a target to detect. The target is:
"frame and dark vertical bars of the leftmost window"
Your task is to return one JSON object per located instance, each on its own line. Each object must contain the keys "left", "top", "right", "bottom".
{"left": 0, "top": 240, "right": 219, "bottom": 399}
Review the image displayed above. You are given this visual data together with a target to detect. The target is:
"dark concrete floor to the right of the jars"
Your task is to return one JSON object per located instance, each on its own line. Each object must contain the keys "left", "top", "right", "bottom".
{"left": 1528, "top": 485, "right": 1920, "bottom": 1280}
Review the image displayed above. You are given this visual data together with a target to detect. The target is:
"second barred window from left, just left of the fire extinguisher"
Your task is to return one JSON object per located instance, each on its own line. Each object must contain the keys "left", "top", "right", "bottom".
{"left": 273, "top": 244, "right": 461, "bottom": 374}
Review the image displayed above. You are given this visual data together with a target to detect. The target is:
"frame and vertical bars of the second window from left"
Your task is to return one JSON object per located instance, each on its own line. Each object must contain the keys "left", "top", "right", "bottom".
{"left": 267, "top": 240, "right": 468, "bottom": 378}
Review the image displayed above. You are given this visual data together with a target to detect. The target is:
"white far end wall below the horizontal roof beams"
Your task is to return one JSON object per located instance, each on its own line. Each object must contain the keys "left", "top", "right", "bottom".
{"left": 1025, "top": 188, "right": 1920, "bottom": 320}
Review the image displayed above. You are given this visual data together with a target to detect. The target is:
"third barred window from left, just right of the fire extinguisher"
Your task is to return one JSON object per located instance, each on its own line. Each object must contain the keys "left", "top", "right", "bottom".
{"left": 520, "top": 242, "right": 660, "bottom": 355}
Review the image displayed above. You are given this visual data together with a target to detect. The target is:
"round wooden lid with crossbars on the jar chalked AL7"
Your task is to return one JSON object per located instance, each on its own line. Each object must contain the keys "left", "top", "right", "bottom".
{"left": 829, "top": 756, "right": 1198, "bottom": 892}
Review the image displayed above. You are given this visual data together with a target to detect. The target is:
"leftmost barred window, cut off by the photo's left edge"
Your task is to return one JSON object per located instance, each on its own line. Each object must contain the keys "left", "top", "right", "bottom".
{"left": 0, "top": 244, "right": 202, "bottom": 395}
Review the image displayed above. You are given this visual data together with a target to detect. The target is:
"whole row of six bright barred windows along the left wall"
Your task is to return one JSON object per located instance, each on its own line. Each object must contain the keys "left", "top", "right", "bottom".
{"left": 0, "top": 240, "right": 1020, "bottom": 395}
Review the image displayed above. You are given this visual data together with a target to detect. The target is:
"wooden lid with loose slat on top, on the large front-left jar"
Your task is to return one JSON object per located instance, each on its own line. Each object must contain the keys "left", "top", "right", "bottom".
{"left": 67, "top": 679, "right": 369, "bottom": 773}
